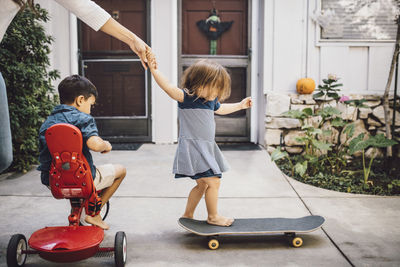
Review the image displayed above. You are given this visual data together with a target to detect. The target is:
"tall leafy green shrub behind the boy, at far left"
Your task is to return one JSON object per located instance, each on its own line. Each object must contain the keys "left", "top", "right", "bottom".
{"left": 0, "top": 4, "right": 59, "bottom": 172}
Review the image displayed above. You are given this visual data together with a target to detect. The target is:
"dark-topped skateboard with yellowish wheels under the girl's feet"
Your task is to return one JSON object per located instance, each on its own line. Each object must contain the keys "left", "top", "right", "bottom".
{"left": 178, "top": 216, "right": 325, "bottom": 249}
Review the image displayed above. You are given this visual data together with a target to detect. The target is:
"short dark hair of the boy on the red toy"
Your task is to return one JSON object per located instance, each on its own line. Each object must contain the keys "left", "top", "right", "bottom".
{"left": 58, "top": 74, "right": 98, "bottom": 104}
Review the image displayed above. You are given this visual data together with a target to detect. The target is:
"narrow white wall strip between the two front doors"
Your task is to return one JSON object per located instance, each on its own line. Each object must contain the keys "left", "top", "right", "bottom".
{"left": 150, "top": 0, "right": 178, "bottom": 143}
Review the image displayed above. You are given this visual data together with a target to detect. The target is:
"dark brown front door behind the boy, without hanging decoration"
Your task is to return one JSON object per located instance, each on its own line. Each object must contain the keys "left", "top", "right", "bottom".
{"left": 79, "top": 0, "right": 151, "bottom": 142}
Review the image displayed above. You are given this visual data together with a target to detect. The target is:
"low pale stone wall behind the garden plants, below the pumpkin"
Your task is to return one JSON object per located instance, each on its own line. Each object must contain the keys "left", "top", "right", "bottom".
{"left": 265, "top": 94, "right": 400, "bottom": 155}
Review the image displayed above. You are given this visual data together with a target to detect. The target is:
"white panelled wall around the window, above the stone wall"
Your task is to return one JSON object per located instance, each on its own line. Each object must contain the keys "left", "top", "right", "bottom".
{"left": 264, "top": 0, "right": 394, "bottom": 94}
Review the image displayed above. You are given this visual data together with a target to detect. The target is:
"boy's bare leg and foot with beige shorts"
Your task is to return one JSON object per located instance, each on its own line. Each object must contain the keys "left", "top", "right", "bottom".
{"left": 85, "top": 164, "right": 126, "bottom": 230}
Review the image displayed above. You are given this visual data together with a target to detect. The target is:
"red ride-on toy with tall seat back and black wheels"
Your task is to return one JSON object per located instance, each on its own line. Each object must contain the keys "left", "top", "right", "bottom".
{"left": 7, "top": 123, "right": 127, "bottom": 267}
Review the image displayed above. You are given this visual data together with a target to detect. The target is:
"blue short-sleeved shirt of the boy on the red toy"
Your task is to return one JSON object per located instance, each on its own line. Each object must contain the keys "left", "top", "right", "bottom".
{"left": 37, "top": 105, "right": 99, "bottom": 185}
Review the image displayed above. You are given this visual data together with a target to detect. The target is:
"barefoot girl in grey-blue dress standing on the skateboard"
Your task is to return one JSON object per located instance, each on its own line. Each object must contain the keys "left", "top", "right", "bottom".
{"left": 147, "top": 49, "right": 252, "bottom": 226}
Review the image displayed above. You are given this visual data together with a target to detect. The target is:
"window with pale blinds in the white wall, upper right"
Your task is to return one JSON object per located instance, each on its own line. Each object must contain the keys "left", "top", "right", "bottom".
{"left": 314, "top": 0, "right": 400, "bottom": 41}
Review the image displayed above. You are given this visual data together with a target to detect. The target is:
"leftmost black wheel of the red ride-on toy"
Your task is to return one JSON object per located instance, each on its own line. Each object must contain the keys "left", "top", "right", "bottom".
{"left": 7, "top": 234, "right": 28, "bottom": 267}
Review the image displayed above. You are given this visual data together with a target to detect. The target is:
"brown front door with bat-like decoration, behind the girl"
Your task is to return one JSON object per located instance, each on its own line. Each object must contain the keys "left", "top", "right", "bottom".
{"left": 179, "top": 0, "right": 251, "bottom": 142}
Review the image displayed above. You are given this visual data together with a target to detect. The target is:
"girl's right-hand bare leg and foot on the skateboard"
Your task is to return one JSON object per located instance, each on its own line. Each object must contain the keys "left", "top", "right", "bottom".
{"left": 200, "top": 177, "right": 234, "bottom": 226}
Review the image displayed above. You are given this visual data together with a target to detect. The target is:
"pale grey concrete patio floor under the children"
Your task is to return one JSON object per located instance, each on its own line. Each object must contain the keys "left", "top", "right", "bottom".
{"left": 0, "top": 144, "right": 400, "bottom": 266}
